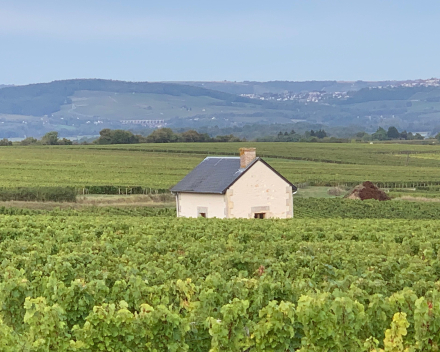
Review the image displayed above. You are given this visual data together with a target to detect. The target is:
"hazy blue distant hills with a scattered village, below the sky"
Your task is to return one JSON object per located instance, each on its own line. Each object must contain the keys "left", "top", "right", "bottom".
{"left": 0, "top": 79, "right": 440, "bottom": 138}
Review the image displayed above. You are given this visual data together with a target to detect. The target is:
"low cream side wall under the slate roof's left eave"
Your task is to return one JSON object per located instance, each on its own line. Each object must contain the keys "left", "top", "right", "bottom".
{"left": 177, "top": 193, "right": 226, "bottom": 218}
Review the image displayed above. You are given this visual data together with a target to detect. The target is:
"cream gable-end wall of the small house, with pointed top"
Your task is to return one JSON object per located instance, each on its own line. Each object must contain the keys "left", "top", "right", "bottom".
{"left": 226, "top": 161, "right": 293, "bottom": 219}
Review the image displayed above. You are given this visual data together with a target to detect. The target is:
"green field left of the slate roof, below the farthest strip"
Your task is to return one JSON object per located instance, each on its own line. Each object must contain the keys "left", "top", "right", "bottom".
{"left": 0, "top": 147, "right": 201, "bottom": 188}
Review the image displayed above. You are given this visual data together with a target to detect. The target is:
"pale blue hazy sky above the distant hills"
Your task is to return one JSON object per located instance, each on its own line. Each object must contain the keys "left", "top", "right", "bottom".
{"left": 0, "top": 0, "right": 440, "bottom": 84}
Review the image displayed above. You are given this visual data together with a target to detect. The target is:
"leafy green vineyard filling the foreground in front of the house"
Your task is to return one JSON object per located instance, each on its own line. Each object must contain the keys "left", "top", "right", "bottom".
{"left": 0, "top": 213, "right": 440, "bottom": 352}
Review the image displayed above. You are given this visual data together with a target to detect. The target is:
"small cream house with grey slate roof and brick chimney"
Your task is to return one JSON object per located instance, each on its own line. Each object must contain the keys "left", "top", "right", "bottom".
{"left": 171, "top": 148, "right": 297, "bottom": 219}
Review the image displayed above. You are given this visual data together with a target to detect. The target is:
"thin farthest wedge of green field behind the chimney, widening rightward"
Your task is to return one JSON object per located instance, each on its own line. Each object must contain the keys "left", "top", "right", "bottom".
{"left": 85, "top": 142, "right": 440, "bottom": 167}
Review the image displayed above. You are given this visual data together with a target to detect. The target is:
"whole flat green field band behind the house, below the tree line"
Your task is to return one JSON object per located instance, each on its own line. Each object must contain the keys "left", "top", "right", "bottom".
{"left": 0, "top": 143, "right": 440, "bottom": 189}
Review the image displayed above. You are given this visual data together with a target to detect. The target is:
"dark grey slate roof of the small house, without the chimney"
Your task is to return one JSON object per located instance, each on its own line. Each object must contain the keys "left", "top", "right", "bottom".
{"left": 171, "top": 157, "right": 296, "bottom": 194}
